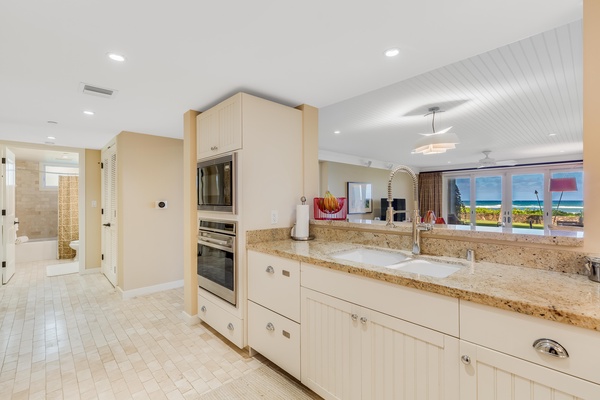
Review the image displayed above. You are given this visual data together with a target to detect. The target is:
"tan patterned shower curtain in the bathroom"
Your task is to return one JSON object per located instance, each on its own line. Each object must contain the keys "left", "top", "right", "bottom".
{"left": 58, "top": 175, "right": 79, "bottom": 260}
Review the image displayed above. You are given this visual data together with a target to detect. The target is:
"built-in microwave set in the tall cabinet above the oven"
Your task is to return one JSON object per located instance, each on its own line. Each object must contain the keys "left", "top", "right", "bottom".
{"left": 196, "top": 153, "right": 236, "bottom": 214}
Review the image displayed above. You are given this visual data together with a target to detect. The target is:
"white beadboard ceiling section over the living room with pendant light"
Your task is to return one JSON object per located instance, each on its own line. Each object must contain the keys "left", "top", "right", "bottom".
{"left": 319, "top": 21, "right": 583, "bottom": 170}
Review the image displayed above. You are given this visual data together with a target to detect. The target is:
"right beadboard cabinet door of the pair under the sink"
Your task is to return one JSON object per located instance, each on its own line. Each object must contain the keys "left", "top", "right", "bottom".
{"left": 366, "top": 311, "right": 459, "bottom": 400}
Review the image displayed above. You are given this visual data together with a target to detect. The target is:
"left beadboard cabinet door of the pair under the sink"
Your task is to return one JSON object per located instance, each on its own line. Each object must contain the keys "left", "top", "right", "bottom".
{"left": 300, "top": 288, "right": 362, "bottom": 399}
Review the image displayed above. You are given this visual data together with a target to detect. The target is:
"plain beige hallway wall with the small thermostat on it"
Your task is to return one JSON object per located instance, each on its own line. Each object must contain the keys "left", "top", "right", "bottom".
{"left": 117, "top": 132, "right": 183, "bottom": 292}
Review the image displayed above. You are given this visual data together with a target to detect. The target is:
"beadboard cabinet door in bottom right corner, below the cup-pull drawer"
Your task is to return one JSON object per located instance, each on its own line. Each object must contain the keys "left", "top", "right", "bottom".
{"left": 460, "top": 341, "right": 600, "bottom": 400}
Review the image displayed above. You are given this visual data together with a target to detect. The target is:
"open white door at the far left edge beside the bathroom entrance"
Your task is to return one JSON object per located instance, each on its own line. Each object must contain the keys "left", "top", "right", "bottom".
{"left": 0, "top": 146, "right": 17, "bottom": 285}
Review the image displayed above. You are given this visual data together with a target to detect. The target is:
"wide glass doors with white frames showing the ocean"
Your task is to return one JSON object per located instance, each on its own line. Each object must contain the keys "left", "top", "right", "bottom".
{"left": 443, "top": 163, "right": 583, "bottom": 229}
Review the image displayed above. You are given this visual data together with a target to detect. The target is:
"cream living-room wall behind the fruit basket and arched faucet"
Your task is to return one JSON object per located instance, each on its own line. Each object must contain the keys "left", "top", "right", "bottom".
{"left": 320, "top": 161, "right": 414, "bottom": 219}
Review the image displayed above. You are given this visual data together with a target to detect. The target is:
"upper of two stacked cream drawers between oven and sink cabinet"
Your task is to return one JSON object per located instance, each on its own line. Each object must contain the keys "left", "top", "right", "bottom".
{"left": 248, "top": 251, "right": 300, "bottom": 322}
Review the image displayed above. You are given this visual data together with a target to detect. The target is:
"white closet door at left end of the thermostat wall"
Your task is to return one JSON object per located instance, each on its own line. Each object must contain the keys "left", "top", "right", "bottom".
{"left": 101, "top": 145, "right": 118, "bottom": 287}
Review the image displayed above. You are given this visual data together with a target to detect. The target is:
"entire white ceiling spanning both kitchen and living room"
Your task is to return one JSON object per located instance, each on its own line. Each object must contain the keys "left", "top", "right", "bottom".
{"left": 0, "top": 0, "right": 583, "bottom": 168}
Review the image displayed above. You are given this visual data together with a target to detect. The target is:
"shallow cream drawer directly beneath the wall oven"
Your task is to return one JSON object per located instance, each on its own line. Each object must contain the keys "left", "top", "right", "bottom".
{"left": 198, "top": 295, "right": 244, "bottom": 349}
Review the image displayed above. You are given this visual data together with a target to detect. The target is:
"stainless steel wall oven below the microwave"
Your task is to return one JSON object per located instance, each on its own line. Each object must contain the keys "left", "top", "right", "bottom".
{"left": 198, "top": 220, "right": 237, "bottom": 305}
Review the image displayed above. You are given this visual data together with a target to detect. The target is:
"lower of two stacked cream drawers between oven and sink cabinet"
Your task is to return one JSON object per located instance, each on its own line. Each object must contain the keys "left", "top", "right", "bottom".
{"left": 248, "top": 301, "right": 300, "bottom": 380}
